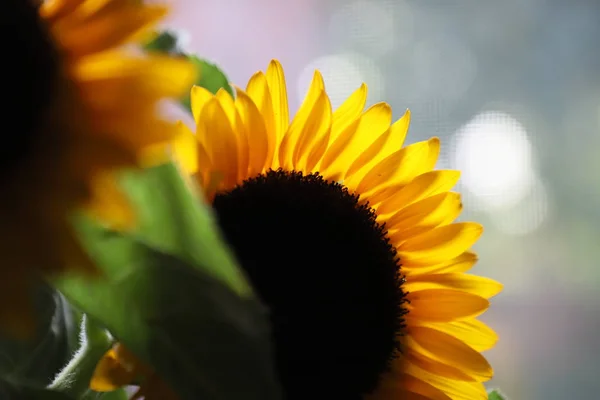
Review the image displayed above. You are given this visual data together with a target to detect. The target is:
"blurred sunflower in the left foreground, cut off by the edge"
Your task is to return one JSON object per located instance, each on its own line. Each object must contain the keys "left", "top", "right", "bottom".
{"left": 0, "top": 0, "right": 194, "bottom": 335}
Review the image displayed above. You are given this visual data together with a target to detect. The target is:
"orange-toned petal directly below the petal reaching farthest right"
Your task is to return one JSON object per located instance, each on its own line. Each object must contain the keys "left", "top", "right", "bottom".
{"left": 406, "top": 289, "right": 490, "bottom": 322}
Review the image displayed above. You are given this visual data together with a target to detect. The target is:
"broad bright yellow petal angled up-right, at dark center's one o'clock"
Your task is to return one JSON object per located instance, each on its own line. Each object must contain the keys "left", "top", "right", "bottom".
{"left": 321, "top": 103, "right": 392, "bottom": 176}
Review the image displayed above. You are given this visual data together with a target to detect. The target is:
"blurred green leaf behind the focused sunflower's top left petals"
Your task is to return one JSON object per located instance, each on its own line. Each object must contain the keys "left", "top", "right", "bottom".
{"left": 144, "top": 31, "right": 234, "bottom": 110}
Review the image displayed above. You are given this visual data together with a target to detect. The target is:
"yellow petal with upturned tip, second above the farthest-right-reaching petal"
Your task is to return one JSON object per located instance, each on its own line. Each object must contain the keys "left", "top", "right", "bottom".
{"left": 398, "top": 222, "right": 483, "bottom": 265}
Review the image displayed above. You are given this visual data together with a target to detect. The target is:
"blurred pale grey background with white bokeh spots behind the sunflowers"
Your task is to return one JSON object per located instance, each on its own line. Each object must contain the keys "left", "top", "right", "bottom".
{"left": 169, "top": 0, "right": 600, "bottom": 400}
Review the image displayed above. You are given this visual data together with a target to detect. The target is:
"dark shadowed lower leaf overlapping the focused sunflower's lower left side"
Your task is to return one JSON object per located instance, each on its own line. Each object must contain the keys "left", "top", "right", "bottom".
{"left": 59, "top": 236, "right": 280, "bottom": 400}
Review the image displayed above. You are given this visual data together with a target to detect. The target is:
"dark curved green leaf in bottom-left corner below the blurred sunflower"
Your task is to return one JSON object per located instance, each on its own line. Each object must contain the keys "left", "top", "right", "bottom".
{"left": 0, "top": 282, "right": 78, "bottom": 386}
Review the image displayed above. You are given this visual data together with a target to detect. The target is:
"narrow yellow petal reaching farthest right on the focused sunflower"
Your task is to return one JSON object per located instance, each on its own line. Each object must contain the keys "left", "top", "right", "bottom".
{"left": 404, "top": 273, "right": 502, "bottom": 299}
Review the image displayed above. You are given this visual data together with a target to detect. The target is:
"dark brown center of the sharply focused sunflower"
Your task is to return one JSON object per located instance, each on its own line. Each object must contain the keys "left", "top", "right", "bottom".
{"left": 214, "top": 170, "right": 406, "bottom": 400}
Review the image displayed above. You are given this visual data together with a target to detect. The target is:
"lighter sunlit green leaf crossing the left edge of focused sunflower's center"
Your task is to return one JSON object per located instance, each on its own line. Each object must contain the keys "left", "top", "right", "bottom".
{"left": 118, "top": 164, "right": 252, "bottom": 296}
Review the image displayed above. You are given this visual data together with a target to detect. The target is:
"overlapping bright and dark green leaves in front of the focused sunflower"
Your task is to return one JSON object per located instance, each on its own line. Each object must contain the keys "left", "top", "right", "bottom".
{"left": 56, "top": 165, "right": 280, "bottom": 400}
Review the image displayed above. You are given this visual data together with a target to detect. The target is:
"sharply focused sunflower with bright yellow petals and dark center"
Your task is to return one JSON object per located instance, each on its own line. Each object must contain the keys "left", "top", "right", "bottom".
{"left": 90, "top": 61, "right": 501, "bottom": 400}
